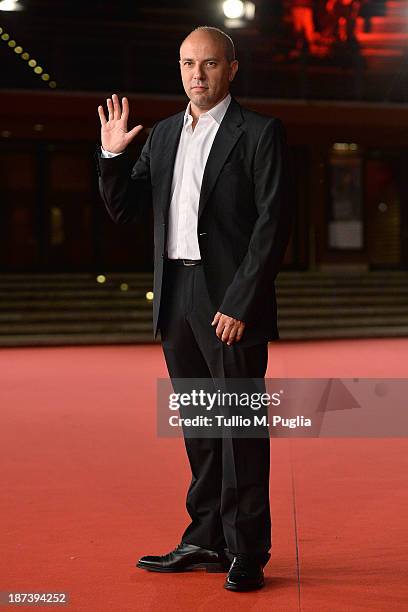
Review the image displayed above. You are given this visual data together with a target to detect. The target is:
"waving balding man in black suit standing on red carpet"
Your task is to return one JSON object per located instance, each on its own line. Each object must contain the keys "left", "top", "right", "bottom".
{"left": 98, "top": 27, "right": 292, "bottom": 591}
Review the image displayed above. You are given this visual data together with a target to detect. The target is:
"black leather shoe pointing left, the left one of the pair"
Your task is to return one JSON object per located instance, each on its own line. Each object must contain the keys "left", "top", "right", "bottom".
{"left": 136, "top": 542, "right": 230, "bottom": 572}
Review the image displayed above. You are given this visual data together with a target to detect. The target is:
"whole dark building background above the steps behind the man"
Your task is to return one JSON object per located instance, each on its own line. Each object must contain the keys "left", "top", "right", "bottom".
{"left": 0, "top": 0, "right": 408, "bottom": 272}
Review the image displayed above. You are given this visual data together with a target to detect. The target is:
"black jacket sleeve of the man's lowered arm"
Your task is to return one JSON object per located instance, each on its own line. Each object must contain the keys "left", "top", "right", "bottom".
{"left": 219, "top": 118, "right": 293, "bottom": 321}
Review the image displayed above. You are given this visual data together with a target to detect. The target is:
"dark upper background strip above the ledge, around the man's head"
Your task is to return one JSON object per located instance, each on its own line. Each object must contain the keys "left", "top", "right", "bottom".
{"left": 0, "top": 0, "right": 402, "bottom": 102}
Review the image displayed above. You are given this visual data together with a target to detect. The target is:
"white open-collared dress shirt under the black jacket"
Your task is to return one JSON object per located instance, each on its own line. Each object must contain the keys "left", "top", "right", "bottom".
{"left": 102, "top": 94, "right": 231, "bottom": 259}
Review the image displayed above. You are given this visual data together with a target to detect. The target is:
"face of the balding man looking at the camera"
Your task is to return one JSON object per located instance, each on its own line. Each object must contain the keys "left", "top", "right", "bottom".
{"left": 180, "top": 32, "right": 238, "bottom": 111}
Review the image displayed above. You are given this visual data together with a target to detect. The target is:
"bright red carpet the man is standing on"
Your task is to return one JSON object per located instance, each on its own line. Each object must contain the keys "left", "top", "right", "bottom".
{"left": 0, "top": 339, "right": 408, "bottom": 612}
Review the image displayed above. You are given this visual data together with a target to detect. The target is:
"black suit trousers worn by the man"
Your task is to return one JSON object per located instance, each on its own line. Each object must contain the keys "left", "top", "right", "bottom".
{"left": 160, "top": 261, "right": 271, "bottom": 559}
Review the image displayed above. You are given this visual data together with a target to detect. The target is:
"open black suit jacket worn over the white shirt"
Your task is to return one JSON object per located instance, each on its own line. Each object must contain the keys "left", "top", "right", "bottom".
{"left": 97, "top": 98, "right": 293, "bottom": 345}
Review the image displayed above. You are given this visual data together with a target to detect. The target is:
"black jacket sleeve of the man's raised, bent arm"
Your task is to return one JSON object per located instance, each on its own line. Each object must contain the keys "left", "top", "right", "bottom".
{"left": 96, "top": 126, "right": 156, "bottom": 223}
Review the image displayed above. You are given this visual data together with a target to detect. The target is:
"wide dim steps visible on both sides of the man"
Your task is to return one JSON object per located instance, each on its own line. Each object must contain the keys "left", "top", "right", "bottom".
{"left": 0, "top": 271, "right": 408, "bottom": 347}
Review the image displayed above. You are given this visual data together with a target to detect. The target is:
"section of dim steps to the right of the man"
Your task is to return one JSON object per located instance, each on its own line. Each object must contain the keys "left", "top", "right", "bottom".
{"left": 277, "top": 271, "right": 408, "bottom": 340}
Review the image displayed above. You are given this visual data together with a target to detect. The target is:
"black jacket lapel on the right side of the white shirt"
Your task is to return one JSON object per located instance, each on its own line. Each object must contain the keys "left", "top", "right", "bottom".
{"left": 198, "top": 98, "right": 244, "bottom": 218}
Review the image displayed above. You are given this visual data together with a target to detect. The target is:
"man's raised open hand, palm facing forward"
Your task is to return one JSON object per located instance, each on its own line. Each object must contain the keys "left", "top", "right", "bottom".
{"left": 98, "top": 94, "right": 143, "bottom": 153}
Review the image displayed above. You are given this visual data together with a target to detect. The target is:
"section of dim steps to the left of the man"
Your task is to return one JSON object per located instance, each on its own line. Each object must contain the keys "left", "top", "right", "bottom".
{"left": 0, "top": 274, "right": 153, "bottom": 346}
